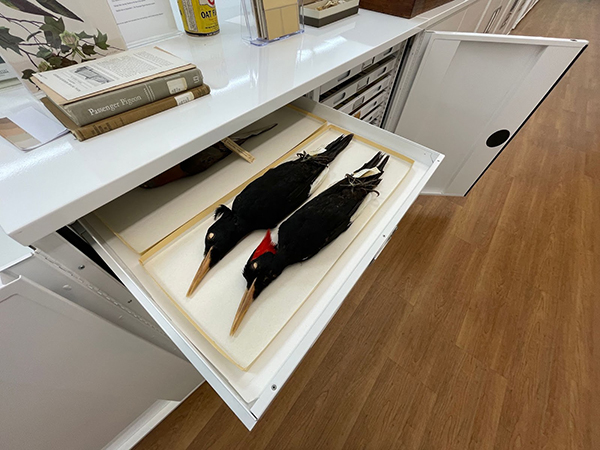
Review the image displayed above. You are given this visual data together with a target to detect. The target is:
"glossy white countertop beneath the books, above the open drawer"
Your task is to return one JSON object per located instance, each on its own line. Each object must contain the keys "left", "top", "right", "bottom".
{"left": 0, "top": 0, "right": 472, "bottom": 245}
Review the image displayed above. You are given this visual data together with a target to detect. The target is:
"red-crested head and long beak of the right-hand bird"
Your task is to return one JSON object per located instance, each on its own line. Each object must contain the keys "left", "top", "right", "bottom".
{"left": 230, "top": 231, "right": 284, "bottom": 336}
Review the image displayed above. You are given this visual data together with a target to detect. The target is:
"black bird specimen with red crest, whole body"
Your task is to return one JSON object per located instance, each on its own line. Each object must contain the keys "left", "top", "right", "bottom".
{"left": 230, "top": 152, "right": 389, "bottom": 336}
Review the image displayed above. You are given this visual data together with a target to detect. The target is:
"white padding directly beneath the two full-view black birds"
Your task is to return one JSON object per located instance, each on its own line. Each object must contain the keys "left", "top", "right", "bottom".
{"left": 144, "top": 130, "right": 411, "bottom": 369}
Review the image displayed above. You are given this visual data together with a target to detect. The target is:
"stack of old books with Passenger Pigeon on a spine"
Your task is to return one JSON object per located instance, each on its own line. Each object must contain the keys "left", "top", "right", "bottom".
{"left": 33, "top": 48, "right": 210, "bottom": 141}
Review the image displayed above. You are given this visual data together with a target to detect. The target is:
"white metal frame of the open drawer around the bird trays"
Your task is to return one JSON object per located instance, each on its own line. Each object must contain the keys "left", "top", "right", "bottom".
{"left": 80, "top": 98, "right": 443, "bottom": 429}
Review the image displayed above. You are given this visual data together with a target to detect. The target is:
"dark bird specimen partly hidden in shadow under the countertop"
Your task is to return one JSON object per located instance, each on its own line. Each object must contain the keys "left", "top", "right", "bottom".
{"left": 141, "top": 123, "right": 277, "bottom": 189}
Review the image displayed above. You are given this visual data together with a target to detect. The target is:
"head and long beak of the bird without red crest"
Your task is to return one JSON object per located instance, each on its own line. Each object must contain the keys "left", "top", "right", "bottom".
{"left": 186, "top": 205, "right": 246, "bottom": 297}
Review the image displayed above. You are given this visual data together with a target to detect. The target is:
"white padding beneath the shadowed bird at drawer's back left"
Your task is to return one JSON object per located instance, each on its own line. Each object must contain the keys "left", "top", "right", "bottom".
{"left": 95, "top": 107, "right": 324, "bottom": 254}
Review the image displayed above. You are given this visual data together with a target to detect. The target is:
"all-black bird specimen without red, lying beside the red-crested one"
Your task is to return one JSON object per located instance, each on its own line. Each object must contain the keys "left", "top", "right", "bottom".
{"left": 187, "top": 134, "right": 354, "bottom": 297}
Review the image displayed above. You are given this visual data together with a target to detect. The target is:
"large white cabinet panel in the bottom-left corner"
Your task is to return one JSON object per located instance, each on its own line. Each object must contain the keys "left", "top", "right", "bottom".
{"left": 0, "top": 273, "right": 201, "bottom": 450}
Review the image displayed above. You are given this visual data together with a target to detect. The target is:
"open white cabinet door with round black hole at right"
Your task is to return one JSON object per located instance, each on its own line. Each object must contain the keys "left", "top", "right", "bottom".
{"left": 386, "top": 32, "right": 587, "bottom": 196}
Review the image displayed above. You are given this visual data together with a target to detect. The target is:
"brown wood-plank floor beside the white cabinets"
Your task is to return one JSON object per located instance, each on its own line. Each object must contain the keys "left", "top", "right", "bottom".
{"left": 138, "top": 0, "right": 600, "bottom": 450}
